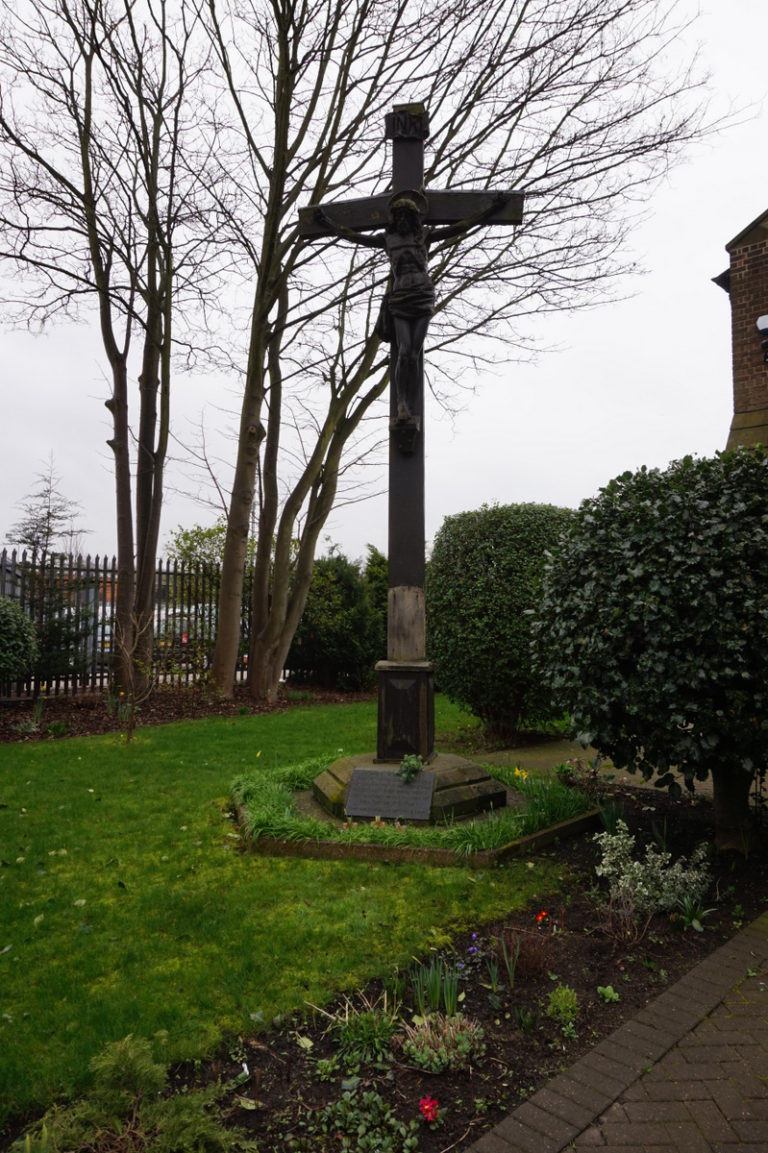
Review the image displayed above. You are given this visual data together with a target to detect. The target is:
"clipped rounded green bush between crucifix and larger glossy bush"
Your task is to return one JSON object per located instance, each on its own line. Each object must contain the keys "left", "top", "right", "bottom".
{"left": 426, "top": 504, "right": 572, "bottom": 738}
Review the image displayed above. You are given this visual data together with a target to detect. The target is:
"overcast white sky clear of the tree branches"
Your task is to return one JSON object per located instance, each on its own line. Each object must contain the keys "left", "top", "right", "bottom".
{"left": 0, "top": 0, "right": 768, "bottom": 558}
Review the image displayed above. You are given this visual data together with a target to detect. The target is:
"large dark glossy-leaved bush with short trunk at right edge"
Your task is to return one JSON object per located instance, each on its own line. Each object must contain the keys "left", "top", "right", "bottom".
{"left": 533, "top": 446, "right": 768, "bottom": 852}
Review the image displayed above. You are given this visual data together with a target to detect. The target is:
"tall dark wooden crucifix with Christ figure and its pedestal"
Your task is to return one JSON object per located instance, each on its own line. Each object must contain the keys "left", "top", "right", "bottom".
{"left": 299, "top": 104, "right": 522, "bottom": 763}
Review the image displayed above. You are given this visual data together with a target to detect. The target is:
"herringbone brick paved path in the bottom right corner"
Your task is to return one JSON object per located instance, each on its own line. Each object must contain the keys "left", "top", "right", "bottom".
{"left": 468, "top": 913, "right": 768, "bottom": 1153}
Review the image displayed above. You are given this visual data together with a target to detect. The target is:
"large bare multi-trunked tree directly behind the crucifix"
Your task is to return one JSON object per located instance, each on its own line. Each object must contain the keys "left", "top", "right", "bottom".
{"left": 208, "top": 0, "right": 703, "bottom": 699}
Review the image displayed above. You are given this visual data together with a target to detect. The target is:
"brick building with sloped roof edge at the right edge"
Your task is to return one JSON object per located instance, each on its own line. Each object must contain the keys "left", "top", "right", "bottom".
{"left": 714, "top": 210, "right": 768, "bottom": 449}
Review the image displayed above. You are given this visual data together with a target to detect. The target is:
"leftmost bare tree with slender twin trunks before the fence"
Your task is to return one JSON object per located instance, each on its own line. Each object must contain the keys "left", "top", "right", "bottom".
{"left": 0, "top": 0, "right": 221, "bottom": 685}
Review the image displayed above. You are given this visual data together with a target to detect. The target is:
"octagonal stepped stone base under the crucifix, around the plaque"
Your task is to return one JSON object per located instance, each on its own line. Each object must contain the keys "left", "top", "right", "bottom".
{"left": 313, "top": 753, "right": 506, "bottom": 824}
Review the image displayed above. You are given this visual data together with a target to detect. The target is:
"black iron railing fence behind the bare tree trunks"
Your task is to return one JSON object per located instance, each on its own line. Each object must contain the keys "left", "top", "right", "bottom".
{"left": 0, "top": 549, "right": 249, "bottom": 699}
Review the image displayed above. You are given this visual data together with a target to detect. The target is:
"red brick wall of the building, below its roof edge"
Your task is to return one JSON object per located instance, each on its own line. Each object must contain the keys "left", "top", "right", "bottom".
{"left": 730, "top": 238, "right": 768, "bottom": 414}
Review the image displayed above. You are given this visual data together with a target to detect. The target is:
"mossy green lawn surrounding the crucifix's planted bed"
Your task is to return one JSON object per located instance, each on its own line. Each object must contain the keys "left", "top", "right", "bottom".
{"left": 0, "top": 698, "right": 558, "bottom": 1124}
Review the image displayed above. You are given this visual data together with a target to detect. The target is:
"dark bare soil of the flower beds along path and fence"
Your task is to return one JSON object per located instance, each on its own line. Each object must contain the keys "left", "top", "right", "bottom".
{"left": 0, "top": 691, "right": 768, "bottom": 1153}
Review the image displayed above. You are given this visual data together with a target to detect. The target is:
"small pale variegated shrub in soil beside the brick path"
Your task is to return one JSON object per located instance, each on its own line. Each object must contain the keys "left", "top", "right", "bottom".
{"left": 594, "top": 820, "right": 709, "bottom": 941}
